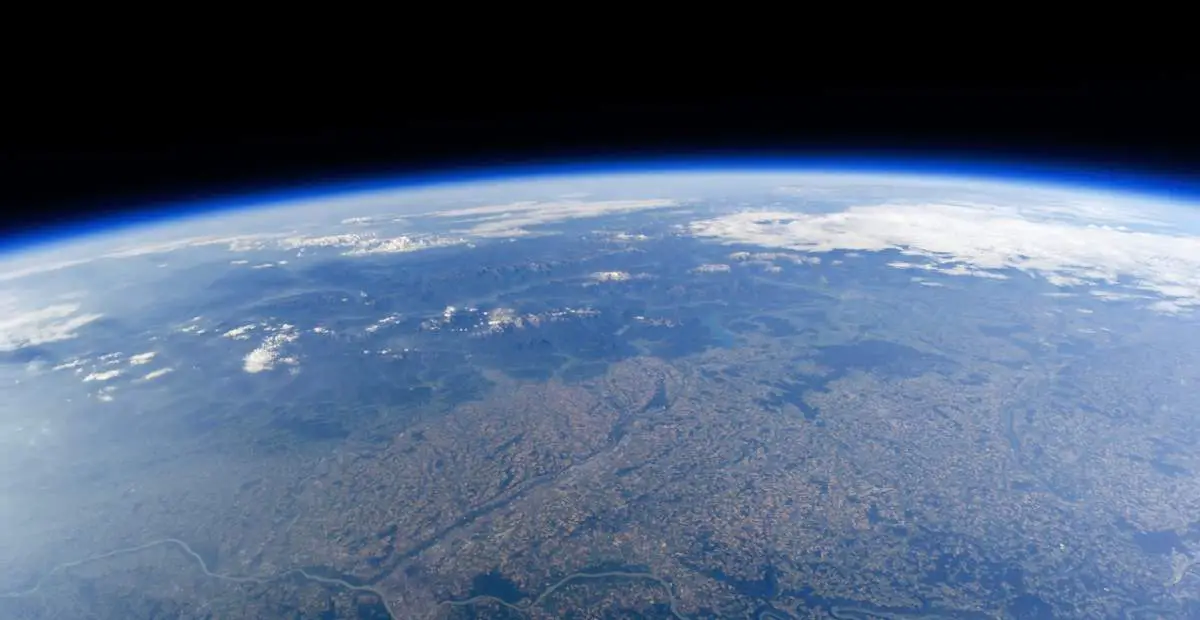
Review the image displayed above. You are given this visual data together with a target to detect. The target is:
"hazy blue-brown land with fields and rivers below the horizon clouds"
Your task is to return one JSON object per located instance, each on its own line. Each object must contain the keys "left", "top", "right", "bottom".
{"left": 0, "top": 195, "right": 1200, "bottom": 620}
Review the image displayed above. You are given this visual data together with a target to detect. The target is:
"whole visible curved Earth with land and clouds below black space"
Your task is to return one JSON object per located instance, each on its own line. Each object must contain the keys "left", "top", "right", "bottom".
{"left": 0, "top": 170, "right": 1200, "bottom": 620}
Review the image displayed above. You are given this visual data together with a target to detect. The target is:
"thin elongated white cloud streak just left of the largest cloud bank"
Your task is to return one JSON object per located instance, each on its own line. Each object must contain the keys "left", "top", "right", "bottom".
{"left": 428, "top": 198, "right": 678, "bottom": 237}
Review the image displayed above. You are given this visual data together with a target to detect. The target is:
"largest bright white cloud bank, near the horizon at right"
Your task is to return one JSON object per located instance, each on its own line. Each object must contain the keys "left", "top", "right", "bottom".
{"left": 691, "top": 204, "right": 1200, "bottom": 312}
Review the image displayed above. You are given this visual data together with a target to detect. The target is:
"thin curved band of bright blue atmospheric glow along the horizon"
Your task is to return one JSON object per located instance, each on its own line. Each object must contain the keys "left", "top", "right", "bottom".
{"left": 7, "top": 154, "right": 1200, "bottom": 255}
